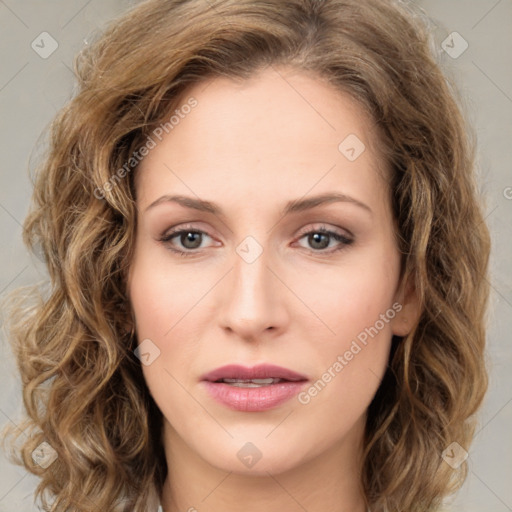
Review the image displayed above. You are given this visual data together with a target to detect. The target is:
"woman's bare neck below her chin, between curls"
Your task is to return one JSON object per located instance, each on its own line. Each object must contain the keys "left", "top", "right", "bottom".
{"left": 161, "top": 419, "right": 366, "bottom": 512}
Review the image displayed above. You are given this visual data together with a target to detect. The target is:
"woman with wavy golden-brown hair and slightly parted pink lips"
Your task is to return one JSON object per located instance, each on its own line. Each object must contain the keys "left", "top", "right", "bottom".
{"left": 3, "top": 0, "right": 489, "bottom": 512}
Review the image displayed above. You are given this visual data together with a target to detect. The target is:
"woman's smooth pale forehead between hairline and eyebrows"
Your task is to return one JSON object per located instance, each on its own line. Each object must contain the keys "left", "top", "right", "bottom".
{"left": 137, "top": 68, "right": 385, "bottom": 208}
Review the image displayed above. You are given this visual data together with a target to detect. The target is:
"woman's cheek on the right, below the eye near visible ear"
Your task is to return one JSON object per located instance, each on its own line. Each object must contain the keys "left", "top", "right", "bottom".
{"left": 299, "top": 245, "right": 399, "bottom": 388}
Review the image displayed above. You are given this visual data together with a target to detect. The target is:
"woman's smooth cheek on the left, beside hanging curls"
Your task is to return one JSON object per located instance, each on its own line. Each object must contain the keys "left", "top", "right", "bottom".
{"left": 129, "top": 247, "right": 214, "bottom": 394}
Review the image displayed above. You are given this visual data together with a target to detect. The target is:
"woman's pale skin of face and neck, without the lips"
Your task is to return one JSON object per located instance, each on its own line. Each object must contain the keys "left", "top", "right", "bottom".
{"left": 128, "top": 68, "right": 418, "bottom": 512}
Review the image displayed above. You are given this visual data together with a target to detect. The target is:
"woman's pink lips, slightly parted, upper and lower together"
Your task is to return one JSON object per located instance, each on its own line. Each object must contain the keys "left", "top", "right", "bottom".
{"left": 201, "top": 364, "right": 308, "bottom": 412}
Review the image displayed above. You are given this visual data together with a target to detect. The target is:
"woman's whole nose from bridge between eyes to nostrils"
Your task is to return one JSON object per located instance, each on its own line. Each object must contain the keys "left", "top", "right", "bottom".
{"left": 220, "top": 236, "right": 286, "bottom": 339}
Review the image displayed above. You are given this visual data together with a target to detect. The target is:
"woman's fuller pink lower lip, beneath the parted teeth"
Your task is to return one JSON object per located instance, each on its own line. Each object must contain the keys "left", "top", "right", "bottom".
{"left": 203, "top": 381, "right": 307, "bottom": 412}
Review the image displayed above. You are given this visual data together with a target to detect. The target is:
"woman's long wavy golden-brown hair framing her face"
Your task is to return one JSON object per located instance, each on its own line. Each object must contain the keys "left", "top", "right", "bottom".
{"left": 5, "top": 0, "right": 490, "bottom": 512}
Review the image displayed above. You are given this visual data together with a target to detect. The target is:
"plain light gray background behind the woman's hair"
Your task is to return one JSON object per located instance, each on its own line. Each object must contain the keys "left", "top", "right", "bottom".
{"left": 0, "top": 0, "right": 512, "bottom": 512}
